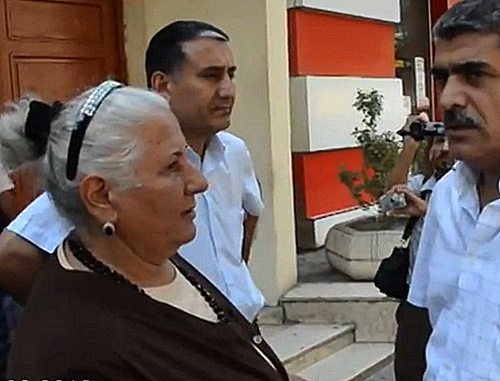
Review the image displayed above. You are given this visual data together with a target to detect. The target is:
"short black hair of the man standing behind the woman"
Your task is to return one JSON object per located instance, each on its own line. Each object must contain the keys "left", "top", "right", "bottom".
{"left": 146, "top": 21, "right": 229, "bottom": 87}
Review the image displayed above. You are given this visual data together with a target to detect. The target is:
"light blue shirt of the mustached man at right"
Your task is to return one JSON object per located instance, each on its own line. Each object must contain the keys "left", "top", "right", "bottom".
{"left": 408, "top": 162, "right": 500, "bottom": 381}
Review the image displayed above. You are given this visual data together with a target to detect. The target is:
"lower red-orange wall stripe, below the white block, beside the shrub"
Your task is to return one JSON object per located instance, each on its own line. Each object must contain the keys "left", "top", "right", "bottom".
{"left": 293, "top": 148, "right": 363, "bottom": 219}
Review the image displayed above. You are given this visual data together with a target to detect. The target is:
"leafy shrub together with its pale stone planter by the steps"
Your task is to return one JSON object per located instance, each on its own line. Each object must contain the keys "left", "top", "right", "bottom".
{"left": 325, "top": 89, "right": 412, "bottom": 280}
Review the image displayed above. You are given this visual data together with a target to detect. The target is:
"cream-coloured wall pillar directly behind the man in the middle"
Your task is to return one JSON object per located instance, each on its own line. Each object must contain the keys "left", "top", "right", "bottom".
{"left": 125, "top": 0, "right": 297, "bottom": 304}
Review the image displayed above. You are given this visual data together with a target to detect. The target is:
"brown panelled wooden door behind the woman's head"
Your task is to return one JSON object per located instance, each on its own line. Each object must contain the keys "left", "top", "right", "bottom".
{"left": 0, "top": 0, "right": 126, "bottom": 217}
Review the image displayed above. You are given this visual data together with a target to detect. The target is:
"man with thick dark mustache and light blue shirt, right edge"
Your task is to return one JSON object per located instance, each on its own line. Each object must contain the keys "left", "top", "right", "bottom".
{"left": 408, "top": 0, "right": 500, "bottom": 381}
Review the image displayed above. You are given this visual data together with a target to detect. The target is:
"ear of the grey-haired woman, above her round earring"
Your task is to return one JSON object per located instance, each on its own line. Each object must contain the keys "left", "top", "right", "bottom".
{"left": 79, "top": 175, "right": 117, "bottom": 223}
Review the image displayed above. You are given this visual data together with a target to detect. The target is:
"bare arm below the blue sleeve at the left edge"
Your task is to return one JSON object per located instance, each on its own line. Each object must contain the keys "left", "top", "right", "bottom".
{"left": 0, "top": 230, "right": 48, "bottom": 305}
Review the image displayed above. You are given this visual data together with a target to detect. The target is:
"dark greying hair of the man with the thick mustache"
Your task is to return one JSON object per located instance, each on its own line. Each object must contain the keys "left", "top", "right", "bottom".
{"left": 433, "top": 0, "right": 500, "bottom": 41}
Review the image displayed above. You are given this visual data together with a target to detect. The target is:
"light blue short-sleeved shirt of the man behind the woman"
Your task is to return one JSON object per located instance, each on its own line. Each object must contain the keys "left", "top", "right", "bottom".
{"left": 7, "top": 132, "right": 265, "bottom": 321}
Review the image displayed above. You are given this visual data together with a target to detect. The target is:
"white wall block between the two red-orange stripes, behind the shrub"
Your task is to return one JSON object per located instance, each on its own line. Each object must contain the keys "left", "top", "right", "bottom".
{"left": 290, "top": 77, "right": 408, "bottom": 152}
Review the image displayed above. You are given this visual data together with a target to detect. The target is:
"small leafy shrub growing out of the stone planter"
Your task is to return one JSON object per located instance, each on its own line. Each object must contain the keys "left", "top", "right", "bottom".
{"left": 339, "top": 89, "right": 401, "bottom": 205}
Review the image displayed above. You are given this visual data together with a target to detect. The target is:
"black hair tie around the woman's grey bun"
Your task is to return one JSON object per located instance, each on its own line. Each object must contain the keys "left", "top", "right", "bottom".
{"left": 24, "top": 101, "right": 63, "bottom": 156}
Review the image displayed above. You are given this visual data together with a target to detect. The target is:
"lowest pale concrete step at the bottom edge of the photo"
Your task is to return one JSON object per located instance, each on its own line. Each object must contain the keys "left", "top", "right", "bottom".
{"left": 299, "top": 343, "right": 394, "bottom": 381}
